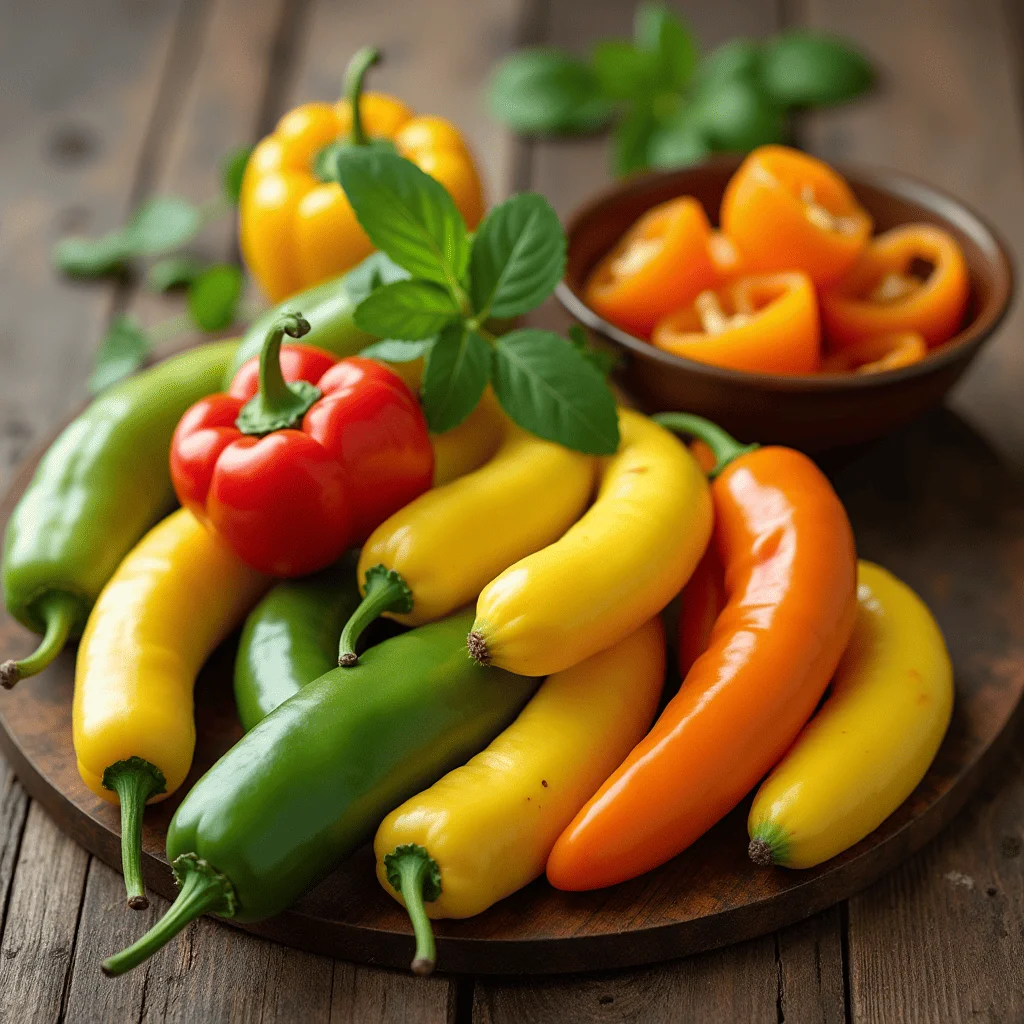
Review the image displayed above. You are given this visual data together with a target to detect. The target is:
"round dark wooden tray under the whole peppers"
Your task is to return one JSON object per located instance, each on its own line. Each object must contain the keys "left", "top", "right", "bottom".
{"left": 0, "top": 412, "right": 1024, "bottom": 974}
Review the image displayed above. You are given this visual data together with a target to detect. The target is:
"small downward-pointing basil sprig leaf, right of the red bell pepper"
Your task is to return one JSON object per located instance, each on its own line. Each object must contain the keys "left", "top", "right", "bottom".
{"left": 421, "top": 324, "right": 492, "bottom": 434}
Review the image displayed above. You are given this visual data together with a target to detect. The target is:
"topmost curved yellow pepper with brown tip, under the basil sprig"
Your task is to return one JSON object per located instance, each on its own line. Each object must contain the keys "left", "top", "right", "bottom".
{"left": 469, "top": 409, "right": 712, "bottom": 676}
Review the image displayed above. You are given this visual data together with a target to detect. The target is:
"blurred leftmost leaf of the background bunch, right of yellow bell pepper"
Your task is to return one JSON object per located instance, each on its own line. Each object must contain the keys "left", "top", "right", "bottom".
{"left": 487, "top": 49, "right": 611, "bottom": 135}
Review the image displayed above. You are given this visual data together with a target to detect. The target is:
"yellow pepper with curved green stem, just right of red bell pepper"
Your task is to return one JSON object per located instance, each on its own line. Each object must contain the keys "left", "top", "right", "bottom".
{"left": 339, "top": 418, "right": 593, "bottom": 666}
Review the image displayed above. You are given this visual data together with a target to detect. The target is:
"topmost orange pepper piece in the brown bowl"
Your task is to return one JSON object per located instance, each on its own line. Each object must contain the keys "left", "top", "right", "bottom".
{"left": 721, "top": 145, "right": 871, "bottom": 287}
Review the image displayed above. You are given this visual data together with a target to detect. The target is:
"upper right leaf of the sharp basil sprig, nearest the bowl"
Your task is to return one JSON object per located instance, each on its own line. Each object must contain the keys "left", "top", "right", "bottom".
{"left": 469, "top": 193, "right": 565, "bottom": 319}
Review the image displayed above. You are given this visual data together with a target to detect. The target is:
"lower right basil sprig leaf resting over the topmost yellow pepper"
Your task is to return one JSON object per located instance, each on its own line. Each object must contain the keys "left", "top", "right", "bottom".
{"left": 494, "top": 328, "right": 618, "bottom": 455}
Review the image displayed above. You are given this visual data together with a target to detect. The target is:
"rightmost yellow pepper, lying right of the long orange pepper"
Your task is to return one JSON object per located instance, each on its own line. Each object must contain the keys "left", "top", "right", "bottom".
{"left": 748, "top": 561, "right": 953, "bottom": 867}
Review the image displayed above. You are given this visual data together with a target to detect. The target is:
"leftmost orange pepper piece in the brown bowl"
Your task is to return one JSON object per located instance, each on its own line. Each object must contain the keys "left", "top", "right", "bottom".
{"left": 584, "top": 196, "right": 717, "bottom": 339}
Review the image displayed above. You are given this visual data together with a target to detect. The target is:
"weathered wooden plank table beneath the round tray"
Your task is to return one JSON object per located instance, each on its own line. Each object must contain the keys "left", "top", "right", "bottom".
{"left": 0, "top": 0, "right": 1024, "bottom": 1024}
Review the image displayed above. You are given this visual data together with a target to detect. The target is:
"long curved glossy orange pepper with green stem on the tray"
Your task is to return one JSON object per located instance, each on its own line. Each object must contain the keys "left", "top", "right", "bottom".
{"left": 548, "top": 413, "right": 856, "bottom": 890}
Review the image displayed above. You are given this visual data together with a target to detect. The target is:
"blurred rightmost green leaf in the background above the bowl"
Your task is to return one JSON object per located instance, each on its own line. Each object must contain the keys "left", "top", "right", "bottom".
{"left": 763, "top": 31, "right": 874, "bottom": 106}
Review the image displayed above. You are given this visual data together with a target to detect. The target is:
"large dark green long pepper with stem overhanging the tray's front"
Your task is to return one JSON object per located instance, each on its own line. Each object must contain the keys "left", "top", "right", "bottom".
{"left": 103, "top": 613, "right": 538, "bottom": 974}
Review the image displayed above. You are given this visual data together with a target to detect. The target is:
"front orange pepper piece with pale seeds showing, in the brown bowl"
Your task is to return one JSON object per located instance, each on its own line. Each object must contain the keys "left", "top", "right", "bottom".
{"left": 651, "top": 271, "right": 821, "bottom": 374}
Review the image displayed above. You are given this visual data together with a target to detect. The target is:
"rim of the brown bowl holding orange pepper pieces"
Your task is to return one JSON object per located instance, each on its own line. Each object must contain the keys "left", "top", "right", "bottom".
{"left": 555, "top": 154, "right": 1016, "bottom": 391}
